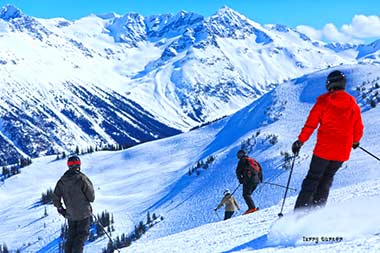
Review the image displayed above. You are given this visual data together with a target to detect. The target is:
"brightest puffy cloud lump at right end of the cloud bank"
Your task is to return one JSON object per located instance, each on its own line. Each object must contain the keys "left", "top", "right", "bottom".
{"left": 341, "top": 15, "right": 380, "bottom": 38}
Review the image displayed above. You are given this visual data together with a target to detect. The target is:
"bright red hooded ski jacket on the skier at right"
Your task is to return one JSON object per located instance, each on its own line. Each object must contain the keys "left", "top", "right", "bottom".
{"left": 298, "top": 90, "right": 364, "bottom": 162}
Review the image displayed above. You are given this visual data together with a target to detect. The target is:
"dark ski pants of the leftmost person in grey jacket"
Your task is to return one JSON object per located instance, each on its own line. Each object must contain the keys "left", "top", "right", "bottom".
{"left": 65, "top": 217, "right": 91, "bottom": 253}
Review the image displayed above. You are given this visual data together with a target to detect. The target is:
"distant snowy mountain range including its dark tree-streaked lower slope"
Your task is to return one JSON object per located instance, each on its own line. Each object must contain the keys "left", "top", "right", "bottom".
{"left": 0, "top": 5, "right": 378, "bottom": 166}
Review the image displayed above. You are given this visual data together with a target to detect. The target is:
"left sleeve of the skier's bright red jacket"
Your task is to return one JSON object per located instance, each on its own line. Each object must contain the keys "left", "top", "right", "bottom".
{"left": 298, "top": 97, "right": 324, "bottom": 143}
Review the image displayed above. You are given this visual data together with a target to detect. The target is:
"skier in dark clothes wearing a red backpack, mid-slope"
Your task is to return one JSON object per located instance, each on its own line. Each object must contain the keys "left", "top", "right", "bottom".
{"left": 236, "top": 150, "right": 262, "bottom": 214}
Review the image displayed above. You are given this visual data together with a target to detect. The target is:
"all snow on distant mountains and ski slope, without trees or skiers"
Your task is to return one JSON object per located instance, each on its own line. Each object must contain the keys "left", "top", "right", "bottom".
{"left": 0, "top": 4, "right": 380, "bottom": 253}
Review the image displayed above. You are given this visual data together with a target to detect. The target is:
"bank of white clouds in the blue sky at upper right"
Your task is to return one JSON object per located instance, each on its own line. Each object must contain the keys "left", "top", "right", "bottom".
{"left": 296, "top": 15, "right": 380, "bottom": 43}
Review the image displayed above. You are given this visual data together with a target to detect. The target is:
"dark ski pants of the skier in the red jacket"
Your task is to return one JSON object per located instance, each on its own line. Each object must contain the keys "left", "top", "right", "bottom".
{"left": 294, "top": 155, "right": 343, "bottom": 209}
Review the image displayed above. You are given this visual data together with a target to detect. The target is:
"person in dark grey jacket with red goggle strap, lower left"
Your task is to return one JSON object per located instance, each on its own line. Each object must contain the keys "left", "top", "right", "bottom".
{"left": 53, "top": 156, "right": 95, "bottom": 253}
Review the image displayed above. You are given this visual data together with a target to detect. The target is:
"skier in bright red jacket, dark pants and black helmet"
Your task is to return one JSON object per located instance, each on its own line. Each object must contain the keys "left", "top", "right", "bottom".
{"left": 292, "top": 70, "right": 364, "bottom": 209}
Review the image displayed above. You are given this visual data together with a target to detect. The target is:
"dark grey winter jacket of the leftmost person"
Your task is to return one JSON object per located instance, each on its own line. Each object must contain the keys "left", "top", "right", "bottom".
{"left": 53, "top": 169, "right": 95, "bottom": 221}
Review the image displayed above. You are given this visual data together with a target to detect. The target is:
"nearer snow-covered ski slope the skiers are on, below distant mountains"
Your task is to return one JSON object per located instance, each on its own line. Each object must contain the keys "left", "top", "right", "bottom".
{"left": 0, "top": 64, "right": 380, "bottom": 253}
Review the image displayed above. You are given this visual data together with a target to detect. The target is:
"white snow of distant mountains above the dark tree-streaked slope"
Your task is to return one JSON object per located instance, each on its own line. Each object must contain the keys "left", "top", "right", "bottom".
{"left": 0, "top": 3, "right": 376, "bottom": 135}
